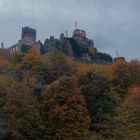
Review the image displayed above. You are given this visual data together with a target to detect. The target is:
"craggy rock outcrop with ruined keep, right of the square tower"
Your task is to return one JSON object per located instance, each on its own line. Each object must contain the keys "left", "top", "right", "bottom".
{"left": 42, "top": 29, "right": 113, "bottom": 64}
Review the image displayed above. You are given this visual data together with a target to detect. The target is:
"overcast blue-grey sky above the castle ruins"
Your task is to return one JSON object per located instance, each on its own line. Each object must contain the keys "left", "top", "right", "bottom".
{"left": 0, "top": 0, "right": 140, "bottom": 60}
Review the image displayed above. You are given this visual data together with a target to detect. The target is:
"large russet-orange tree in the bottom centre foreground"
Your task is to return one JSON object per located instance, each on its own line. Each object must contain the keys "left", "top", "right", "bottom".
{"left": 44, "top": 76, "right": 90, "bottom": 140}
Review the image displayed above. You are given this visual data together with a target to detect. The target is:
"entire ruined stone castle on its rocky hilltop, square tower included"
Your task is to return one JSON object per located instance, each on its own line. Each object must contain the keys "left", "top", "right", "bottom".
{"left": 6, "top": 26, "right": 116, "bottom": 64}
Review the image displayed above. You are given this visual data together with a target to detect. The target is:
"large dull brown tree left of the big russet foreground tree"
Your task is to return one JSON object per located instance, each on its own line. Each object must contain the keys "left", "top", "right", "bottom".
{"left": 4, "top": 83, "right": 46, "bottom": 140}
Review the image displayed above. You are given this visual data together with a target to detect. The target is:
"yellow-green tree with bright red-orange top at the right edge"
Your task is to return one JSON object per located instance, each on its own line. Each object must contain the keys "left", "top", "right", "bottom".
{"left": 114, "top": 86, "right": 140, "bottom": 140}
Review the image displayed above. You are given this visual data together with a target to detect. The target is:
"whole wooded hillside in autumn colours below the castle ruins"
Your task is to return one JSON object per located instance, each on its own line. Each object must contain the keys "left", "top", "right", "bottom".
{"left": 0, "top": 48, "right": 140, "bottom": 140}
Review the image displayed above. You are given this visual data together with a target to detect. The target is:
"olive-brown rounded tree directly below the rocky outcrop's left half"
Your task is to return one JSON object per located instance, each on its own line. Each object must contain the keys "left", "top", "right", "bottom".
{"left": 44, "top": 50, "right": 76, "bottom": 83}
